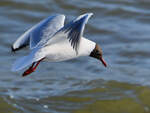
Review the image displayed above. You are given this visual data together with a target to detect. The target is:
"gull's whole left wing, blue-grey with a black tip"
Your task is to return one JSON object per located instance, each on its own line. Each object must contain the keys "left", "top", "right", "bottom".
{"left": 12, "top": 14, "right": 65, "bottom": 51}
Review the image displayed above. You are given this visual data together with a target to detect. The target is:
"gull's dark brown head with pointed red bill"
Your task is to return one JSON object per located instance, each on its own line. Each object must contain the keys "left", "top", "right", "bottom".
{"left": 90, "top": 44, "right": 107, "bottom": 67}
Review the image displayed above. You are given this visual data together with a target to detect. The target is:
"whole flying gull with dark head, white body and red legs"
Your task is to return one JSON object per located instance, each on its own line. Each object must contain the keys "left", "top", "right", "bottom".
{"left": 11, "top": 13, "right": 107, "bottom": 76}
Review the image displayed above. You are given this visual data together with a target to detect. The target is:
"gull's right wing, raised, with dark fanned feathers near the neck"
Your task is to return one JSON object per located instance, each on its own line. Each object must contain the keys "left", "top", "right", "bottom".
{"left": 48, "top": 13, "right": 93, "bottom": 54}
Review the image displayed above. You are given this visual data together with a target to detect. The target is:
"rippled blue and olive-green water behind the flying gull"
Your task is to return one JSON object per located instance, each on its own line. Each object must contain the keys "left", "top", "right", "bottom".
{"left": 0, "top": 0, "right": 150, "bottom": 113}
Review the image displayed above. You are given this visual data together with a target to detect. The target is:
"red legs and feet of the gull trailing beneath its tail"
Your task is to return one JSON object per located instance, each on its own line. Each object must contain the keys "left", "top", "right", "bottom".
{"left": 22, "top": 58, "right": 44, "bottom": 77}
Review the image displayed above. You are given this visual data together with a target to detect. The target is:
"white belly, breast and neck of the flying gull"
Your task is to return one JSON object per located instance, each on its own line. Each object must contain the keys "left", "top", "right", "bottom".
{"left": 42, "top": 38, "right": 95, "bottom": 62}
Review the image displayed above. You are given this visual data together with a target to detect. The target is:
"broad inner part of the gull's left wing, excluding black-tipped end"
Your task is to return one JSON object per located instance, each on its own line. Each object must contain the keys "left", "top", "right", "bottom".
{"left": 30, "top": 15, "right": 65, "bottom": 49}
